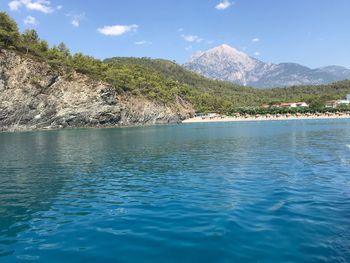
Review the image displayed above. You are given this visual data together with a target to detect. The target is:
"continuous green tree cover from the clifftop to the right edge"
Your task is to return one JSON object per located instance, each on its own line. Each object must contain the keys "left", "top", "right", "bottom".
{"left": 0, "top": 12, "right": 350, "bottom": 114}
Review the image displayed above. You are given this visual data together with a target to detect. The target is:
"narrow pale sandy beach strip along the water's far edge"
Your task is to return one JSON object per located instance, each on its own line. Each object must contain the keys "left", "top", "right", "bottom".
{"left": 182, "top": 115, "right": 350, "bottom": 124}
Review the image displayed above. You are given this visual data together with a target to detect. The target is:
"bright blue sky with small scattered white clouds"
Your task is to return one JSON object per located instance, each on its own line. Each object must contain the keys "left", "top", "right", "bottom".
{"left": 0, "top": 0, "right": 350, "bottom": 68}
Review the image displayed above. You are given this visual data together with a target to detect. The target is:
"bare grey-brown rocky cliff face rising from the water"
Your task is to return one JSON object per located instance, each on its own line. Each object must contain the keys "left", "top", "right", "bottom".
{"left": 0, "top": 50, "right": 193, "bottom": 130}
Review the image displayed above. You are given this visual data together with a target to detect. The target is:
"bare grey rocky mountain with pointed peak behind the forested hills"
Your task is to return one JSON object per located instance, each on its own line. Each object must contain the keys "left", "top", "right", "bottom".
{"left": 184, "top": 44, "right": 350, "bottom": 87}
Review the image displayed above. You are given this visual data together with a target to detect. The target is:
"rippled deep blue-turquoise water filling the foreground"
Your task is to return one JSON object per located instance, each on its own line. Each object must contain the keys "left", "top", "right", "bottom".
{"left": 0, "top": 120, "right": 350, "bottom": 263}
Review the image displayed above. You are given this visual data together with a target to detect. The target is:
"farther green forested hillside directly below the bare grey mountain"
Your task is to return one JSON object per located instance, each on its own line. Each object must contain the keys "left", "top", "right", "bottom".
{"left": 105, "top": 57, "right": 350, "bottom": 110}
